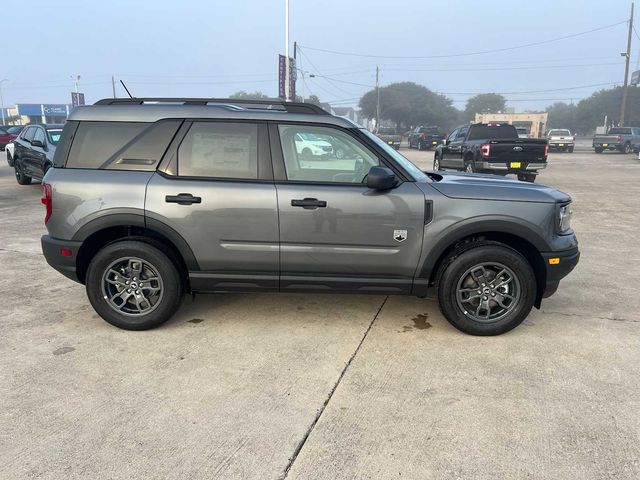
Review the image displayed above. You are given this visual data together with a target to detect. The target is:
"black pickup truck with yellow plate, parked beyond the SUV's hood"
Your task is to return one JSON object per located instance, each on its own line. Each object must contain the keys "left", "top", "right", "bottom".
{"left": 433, "top": 123, "right": 549, "bottom": 182}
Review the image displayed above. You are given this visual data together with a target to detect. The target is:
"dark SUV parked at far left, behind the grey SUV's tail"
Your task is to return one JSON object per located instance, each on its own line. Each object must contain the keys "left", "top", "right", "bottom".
{"left": 13, "top": 124, "right": 62, "bottom": 185}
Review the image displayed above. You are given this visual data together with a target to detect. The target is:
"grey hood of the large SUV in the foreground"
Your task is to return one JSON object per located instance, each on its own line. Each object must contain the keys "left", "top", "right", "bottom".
{"left": 430, "top": 172, "right": 571, "bottom": 203}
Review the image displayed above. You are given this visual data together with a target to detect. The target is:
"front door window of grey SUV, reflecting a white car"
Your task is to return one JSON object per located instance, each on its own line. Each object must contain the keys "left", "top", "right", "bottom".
{"left": 278, "top": 125, "right": 380, "bottom": 183}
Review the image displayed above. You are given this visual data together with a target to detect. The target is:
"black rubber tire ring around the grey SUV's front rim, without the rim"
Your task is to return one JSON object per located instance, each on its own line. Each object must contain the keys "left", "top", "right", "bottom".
{"left": 438, "top": 245, "right": 537, "bottom": 335}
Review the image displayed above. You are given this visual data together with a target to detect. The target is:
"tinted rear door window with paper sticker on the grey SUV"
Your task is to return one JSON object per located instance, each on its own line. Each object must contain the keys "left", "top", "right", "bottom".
{"left": 178, "top": 122, "right": 258, "bottom": 179}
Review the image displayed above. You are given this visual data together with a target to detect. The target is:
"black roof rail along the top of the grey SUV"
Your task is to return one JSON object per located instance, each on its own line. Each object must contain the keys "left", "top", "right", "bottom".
{"left": 94, "top": 97, "right": 329, "bottom": 115}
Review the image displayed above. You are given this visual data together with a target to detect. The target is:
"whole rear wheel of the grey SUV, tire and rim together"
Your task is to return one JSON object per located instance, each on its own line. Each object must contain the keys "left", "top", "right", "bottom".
{"left": 86, "top": 240, "right": 184, "bottom": 330}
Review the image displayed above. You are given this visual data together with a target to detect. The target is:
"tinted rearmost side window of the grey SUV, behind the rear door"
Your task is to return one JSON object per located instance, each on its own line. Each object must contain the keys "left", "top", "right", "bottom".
{"left": 66, "top": 120, "right": 181, "bottom": 171}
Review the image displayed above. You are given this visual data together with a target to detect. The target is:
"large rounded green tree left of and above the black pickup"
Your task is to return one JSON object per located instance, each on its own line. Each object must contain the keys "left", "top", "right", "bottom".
{"left": 360, "top": 82, "right": 458, "bottom": 129}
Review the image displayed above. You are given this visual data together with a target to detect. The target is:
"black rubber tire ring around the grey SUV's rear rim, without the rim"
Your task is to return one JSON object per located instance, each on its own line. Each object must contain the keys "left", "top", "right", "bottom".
{"left": 86, "top": 241, "right": 183, "bottom": 330}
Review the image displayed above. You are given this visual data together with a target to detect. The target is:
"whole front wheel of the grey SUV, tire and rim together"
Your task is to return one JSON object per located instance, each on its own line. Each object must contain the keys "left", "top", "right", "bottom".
{"left": 438, "top": 244, "right": 536, "bottom": 335}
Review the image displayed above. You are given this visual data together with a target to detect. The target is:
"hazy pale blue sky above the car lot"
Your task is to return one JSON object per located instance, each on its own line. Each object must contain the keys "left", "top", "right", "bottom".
{"left": 0, "top": 0, "right": 640, "bottom": 111}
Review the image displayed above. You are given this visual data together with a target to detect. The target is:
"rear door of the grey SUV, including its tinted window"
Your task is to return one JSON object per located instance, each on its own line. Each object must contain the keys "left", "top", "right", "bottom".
{"left": 145, "top": 120, "right": 279, "bottom": 291}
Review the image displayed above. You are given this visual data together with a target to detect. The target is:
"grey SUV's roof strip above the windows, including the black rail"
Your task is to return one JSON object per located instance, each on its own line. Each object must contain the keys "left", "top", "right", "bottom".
{"left": 68, "top": 98, "right": 356, "bottom": 128}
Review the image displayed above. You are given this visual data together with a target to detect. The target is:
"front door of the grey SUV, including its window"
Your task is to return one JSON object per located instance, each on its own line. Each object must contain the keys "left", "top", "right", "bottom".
{"left": 272, "top": 125, "right": 425, "bottom": 293}
